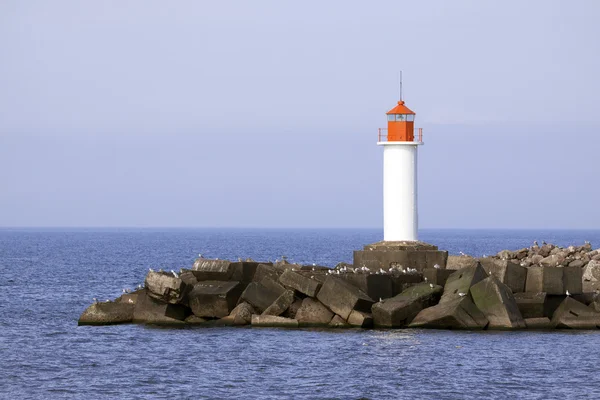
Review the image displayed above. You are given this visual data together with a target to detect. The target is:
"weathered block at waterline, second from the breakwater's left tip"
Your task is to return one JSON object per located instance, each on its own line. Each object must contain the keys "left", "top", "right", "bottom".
{"left": 132, "top": 291, "right": 189, "bottom": 325}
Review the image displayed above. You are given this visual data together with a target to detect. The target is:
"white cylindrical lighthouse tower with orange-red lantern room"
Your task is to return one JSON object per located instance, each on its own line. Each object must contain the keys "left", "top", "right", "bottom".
{"left": 377, "top": 83, "right": 423, "bottom": 242}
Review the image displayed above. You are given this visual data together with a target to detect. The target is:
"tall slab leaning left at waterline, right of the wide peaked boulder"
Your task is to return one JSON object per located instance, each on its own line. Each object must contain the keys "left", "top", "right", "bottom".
{"left": 471, "top": 275, "right": 525, "bottom": 329}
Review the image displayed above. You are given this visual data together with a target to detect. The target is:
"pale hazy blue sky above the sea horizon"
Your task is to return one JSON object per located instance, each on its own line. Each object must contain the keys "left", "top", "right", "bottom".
{"left": 0, "top": 0, "right": 600, "bottom": 229}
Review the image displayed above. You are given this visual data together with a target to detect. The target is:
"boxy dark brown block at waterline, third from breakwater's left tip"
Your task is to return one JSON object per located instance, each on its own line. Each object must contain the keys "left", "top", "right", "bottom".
{"left": 188, "top": 281, "right": 244, "bottom": 318}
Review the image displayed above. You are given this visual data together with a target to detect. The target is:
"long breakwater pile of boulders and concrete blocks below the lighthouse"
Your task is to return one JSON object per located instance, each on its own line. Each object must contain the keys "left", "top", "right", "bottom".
{"left": 78, "top": 242, "right": 600, "bottom": 330}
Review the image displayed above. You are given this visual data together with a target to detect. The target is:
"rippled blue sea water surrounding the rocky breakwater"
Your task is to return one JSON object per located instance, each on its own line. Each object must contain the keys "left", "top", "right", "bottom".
{"left": 0, "top": 229, "right": 600, "bottom": 399}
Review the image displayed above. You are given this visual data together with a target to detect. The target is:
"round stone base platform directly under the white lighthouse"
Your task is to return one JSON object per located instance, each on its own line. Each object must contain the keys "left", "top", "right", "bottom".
{"left": 353, "top": 241, "right": 448, "bottom": 272}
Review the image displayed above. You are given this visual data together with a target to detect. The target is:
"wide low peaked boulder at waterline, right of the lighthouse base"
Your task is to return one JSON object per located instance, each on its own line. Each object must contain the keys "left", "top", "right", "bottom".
{"left": 409, "top": 296, "right": 488, "bottom": 330}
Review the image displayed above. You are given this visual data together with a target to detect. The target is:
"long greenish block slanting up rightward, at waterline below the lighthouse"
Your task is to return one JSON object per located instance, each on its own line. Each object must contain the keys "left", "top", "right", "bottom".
{"left": 371, "top": 283, "right": 444, "bottom": 328}
